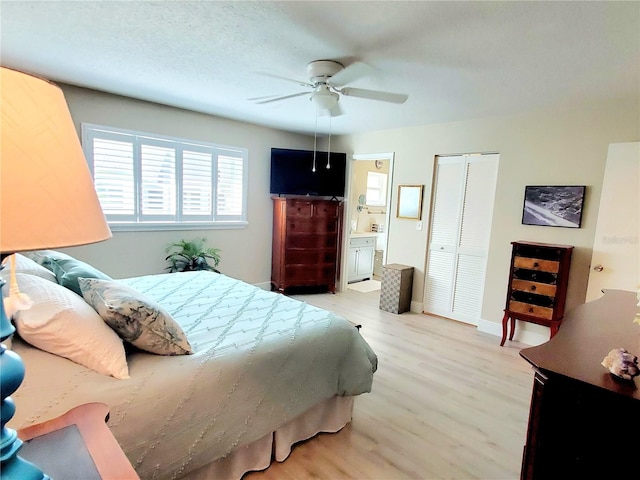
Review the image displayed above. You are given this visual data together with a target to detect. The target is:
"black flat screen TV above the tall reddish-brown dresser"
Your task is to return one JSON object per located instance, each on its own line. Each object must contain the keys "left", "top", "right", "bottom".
{"left": 270, "top": 148, "right": 347, "bottom": 197}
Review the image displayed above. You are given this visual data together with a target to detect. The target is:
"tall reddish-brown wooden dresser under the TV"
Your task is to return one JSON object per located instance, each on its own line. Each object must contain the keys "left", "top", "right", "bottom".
{"left": 271, "top": 197, "right": 342, "bottom": 293}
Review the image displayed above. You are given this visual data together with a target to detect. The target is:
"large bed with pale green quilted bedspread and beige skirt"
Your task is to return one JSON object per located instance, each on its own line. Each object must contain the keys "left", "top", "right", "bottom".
{"left": 2, "top": 253, "right": 377, "bottom": 479}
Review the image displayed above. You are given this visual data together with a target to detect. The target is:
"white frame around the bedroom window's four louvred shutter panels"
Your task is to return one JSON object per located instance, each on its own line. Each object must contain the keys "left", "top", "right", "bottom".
{"left": 82, "top": 123, "right": 249, "bottom": 231}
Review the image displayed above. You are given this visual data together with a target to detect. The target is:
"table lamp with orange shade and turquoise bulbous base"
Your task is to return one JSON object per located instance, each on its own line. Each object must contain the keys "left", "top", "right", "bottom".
{"left": 0, "top": 67, "right": 111, "bottom": 480}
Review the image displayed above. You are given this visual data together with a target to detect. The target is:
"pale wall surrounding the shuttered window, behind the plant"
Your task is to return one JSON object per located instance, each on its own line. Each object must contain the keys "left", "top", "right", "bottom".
{"left": 57, "top": 85, "right": 313, "bottom": 285}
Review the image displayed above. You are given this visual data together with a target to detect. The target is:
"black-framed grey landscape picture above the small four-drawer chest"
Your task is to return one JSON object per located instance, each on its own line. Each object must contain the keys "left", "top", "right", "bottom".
{"left": 522, "top": 185, "right": 587, "bottom": 228}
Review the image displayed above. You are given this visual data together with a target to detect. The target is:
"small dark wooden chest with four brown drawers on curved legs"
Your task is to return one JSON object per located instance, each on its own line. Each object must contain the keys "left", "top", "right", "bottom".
{"left": 500, "top": 241, "right": 573, "bottom": 346}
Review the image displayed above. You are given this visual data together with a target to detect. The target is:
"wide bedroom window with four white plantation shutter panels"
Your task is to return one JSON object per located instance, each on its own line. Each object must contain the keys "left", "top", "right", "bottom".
{"left": 82, "top": 124, "right": 248, "bottom": 230}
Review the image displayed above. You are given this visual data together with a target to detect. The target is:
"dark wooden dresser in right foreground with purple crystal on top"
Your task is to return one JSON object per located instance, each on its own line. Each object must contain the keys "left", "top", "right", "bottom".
{"left": 520, "top": 290, "right": 640, "bottom": 480}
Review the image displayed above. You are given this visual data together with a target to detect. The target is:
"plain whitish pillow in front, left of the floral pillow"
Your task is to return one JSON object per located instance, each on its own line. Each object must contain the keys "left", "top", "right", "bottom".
{"left": 15, "top": 273, "right": 129, "bottom": 379}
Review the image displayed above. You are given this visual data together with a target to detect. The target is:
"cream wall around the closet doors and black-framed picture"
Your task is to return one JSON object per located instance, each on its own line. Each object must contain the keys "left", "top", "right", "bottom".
{"left": 336, "top": 102, "right": 640, "bottom": 338}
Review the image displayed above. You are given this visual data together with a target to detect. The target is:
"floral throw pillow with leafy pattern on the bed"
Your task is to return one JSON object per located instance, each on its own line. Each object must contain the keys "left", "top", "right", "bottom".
{"left": 78, "top": 278, "right": 193, "bottom": 355}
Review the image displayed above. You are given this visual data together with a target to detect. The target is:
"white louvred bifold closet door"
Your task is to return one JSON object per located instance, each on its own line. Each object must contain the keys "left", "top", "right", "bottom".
{"left": 424, "top": 154, "right": 499, "bottom": 325}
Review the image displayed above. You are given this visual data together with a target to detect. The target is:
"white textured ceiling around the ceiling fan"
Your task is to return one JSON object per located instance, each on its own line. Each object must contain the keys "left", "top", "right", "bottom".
{"left": 0, "top": 0, "right": 640, "bottom": 134}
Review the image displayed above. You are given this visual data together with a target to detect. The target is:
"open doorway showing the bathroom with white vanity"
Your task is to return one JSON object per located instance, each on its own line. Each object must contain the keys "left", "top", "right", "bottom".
{"left": 340, "top": 153, "right": 394, "bottom": 293}
